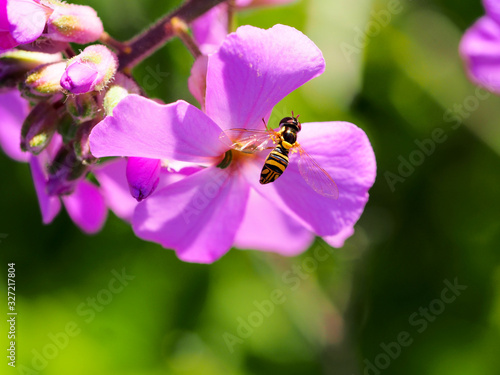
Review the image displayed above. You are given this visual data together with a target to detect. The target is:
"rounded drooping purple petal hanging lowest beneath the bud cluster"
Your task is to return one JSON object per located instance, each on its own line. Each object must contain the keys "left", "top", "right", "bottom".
{"left": 62, "top": 180, "right": 108, "bottom": 234}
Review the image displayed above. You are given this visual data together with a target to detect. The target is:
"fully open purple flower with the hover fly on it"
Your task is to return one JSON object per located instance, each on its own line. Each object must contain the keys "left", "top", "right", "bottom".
{"left": 90, "top": 25, "right": 376, "bottom": 263}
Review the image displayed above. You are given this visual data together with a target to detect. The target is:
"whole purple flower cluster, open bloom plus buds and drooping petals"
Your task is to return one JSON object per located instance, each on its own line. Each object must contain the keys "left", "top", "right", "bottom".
{"left": 0, "top": 0, "right": 376, "bottom": 263}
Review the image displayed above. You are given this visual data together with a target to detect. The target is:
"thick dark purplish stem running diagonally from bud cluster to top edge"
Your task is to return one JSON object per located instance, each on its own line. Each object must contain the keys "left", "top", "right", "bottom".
{"left": 118, "top": 0, "right": 225, "bottom": 70}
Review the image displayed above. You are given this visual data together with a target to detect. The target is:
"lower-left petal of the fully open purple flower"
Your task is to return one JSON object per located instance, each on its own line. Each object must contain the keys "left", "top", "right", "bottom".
{"left": 132, "top": 167, "right": 249, "bottom": 263}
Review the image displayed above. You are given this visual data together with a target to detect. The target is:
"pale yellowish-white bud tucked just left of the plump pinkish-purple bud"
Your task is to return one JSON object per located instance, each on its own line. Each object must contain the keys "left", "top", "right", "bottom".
{"left": 21, "top": 62, "right": 66, "bottom": 99}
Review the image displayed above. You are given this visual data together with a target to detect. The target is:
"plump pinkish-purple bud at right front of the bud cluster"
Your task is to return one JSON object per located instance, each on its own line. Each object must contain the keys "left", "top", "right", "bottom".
{"left": 61, "top": 45, "right": 118, "bottom": 94}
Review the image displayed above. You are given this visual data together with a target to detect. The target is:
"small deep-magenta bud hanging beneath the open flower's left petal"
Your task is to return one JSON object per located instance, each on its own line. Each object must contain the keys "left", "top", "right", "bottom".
{"left": 126, "top": 157, "right": 161, "bottom": 202}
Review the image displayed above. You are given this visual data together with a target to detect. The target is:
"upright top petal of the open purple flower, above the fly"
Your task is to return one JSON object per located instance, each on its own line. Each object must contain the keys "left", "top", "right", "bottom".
{"left": 206, "top": 25, "right": 325, "bottom": 129}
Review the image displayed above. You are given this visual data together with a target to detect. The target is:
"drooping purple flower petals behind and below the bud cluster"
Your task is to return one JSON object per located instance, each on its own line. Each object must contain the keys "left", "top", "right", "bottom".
{"left": 0, "top": 91, "right": 136, "bottom": 233}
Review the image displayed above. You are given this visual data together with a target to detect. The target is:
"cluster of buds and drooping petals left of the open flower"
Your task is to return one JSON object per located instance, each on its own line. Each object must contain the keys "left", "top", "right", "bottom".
{"left": 0, "top": 0, "right": 139, "bottom": 233}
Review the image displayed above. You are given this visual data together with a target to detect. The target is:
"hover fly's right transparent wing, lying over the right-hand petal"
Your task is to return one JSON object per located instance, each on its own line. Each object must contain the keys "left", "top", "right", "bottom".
{"left": 296, "top": 145, "right": 339, "bottom": 199}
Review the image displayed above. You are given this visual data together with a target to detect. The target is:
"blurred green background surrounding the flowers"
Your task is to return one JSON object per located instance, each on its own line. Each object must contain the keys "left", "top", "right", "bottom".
{"left": 0, "top": 0, "right": 500, "bottom": 375}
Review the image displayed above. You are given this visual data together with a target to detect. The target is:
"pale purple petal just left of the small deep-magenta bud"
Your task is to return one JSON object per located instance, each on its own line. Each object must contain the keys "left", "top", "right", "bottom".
{"left": 93, "top": 159, "right": 137, "bottom": 222}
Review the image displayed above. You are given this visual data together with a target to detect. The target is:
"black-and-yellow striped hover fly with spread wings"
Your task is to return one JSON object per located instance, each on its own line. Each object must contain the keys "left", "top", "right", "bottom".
{"left": 219, "top": 112, "right": 339, "bottom": 199}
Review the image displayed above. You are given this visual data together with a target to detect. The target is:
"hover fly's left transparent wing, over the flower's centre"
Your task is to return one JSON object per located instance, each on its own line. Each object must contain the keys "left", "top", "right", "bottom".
{"left": 219, "top": 128, "right": 277, "bottom": 154}
